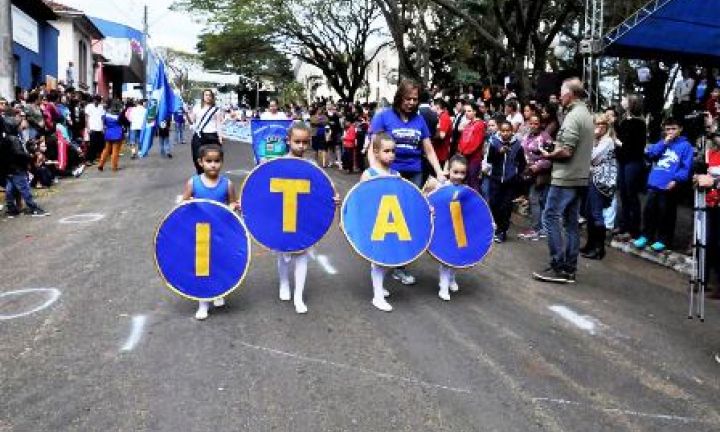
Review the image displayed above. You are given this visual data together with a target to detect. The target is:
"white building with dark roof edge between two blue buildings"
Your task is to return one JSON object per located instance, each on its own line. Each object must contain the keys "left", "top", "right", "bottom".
{"left": 45, "top": 0, "right": 103, "bottom": 90}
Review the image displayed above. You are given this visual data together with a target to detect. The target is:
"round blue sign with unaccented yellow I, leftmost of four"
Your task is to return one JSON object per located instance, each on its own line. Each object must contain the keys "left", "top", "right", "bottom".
{"left": 155, "top": 200, "right": 250, "bottom": 301}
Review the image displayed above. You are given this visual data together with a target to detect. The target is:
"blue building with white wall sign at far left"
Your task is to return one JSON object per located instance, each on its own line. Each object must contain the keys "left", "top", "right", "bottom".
{"left": 11, "top": 0, "right": 59, "bottom": 92}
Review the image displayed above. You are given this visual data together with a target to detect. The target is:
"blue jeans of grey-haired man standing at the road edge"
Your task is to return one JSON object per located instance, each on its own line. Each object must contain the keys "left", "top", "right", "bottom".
{"left": 543, "top": 185, "right": 587, "bottom": 273}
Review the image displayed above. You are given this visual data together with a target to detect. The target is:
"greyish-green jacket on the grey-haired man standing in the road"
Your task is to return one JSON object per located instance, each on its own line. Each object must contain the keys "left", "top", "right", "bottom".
{"left": 550, "top": 100, "right": 595, "bottom": 187}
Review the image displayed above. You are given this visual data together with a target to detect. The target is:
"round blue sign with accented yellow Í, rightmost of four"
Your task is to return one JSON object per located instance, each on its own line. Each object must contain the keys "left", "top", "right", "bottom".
{"left": 428, "top": 185, "right": 493, "bottom": 268}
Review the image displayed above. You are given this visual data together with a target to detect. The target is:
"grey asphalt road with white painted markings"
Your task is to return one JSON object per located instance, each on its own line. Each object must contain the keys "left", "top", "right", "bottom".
{"left": 0, "top": 138, "right": 720, "bottom": 432}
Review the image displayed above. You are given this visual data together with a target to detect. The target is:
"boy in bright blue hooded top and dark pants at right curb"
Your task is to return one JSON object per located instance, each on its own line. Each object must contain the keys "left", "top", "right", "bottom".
{"left": 634, "top": 118, "right": 693, "bottom": 252}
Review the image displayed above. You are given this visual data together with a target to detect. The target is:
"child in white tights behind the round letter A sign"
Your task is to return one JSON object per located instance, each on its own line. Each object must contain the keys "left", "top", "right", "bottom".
{"left": 360, "top": 132, "right": 400, "bottom": 312}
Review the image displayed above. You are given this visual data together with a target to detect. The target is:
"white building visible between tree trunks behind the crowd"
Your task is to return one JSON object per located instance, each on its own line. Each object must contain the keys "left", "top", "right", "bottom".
{"left": 294, "top": 46, "right": 399, "bottom": 102}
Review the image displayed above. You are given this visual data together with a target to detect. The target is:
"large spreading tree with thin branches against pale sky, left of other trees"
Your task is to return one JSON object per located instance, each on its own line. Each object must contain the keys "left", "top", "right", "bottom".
{"left": 176, "top": 0, "right": 386, "bottom": 100}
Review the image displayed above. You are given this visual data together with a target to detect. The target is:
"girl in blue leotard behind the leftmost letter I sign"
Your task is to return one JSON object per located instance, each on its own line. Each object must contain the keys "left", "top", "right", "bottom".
{"left": 183, "top": 144, "right": 238, "bottom": 320}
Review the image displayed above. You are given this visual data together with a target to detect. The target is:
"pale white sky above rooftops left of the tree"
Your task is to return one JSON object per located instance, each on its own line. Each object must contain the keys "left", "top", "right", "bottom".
{"left": 56, "top": 0, "right": 203, "bottom": 52}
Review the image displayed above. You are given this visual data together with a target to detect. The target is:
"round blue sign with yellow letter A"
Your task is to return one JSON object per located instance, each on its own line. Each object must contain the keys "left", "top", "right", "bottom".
{"left": 340, "top": 176, "right": 433, "bottom": 267}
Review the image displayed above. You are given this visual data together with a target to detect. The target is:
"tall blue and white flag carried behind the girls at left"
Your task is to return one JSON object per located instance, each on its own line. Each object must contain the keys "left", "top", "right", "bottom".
{"left": 140, "top": 60, "right": 175, "bottom": 157}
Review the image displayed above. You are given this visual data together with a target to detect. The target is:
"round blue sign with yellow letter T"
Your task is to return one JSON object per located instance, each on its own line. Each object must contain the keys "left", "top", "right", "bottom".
{"left": 241, "top": 157, "right": 335, "bottom": 252}
